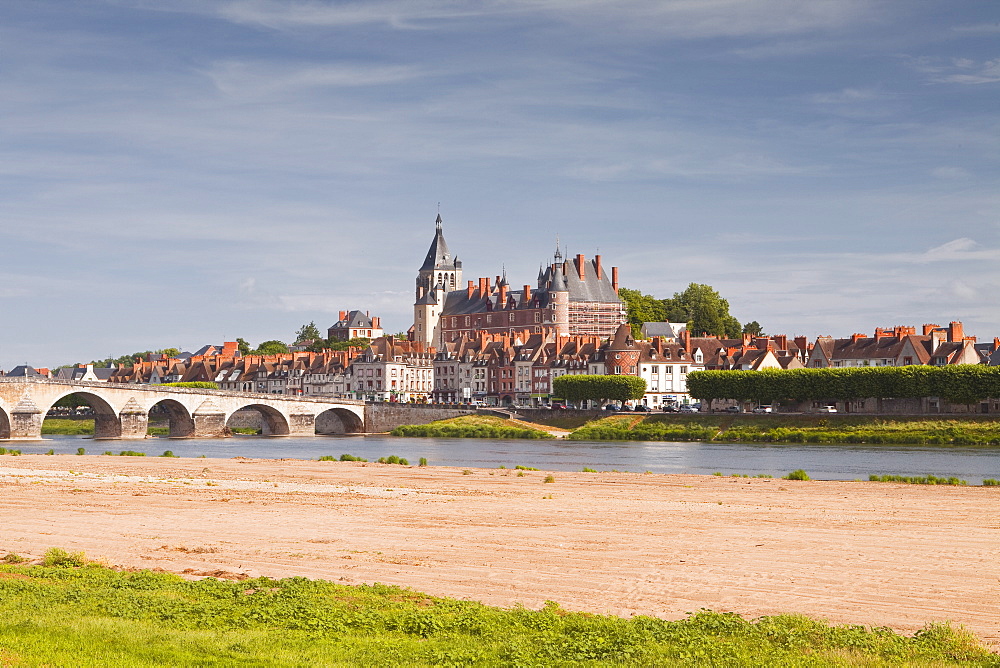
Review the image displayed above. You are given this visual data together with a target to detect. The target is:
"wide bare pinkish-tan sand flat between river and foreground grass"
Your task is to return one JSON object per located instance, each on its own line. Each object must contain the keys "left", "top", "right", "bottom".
{"left": 0, "top": 455, "right": 1000, "bottom": 647}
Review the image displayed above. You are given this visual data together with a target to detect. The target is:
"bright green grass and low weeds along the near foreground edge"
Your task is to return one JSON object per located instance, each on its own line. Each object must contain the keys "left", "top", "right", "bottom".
{"left": 0, "top": 550, "right": 1000, "bottom": 667}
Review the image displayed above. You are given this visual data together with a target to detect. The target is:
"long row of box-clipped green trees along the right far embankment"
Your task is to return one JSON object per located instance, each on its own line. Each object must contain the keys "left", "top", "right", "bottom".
{"left": 687, "top": 364, "right": 1000, "bottom": 404}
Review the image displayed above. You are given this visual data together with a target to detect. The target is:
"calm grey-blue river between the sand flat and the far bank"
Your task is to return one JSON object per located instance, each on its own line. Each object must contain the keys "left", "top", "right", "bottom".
{"left": 9, "top": 435, "right": 1000, "bottom": 485}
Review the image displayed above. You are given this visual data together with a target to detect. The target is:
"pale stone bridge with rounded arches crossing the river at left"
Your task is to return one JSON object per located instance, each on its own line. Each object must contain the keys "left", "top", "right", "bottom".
{"left": 0, "top": 378, "right": 414, "bottom": 440}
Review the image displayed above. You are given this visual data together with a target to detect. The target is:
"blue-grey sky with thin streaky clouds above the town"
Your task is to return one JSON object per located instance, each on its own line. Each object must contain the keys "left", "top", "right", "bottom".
{"left": 0, "top": 0, "right": 1000, "bottom": 369}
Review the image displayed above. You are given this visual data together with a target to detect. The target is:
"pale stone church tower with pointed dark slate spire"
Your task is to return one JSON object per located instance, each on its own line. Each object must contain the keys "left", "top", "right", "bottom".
{"left": 413, "top": 214, "right": 462, "bottom": 346}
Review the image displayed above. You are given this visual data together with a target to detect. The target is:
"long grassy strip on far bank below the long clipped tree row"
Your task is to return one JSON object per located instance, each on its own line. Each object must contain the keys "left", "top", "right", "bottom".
{"left": 567, "top": 415, "right": 1000, "bottom": 445}
